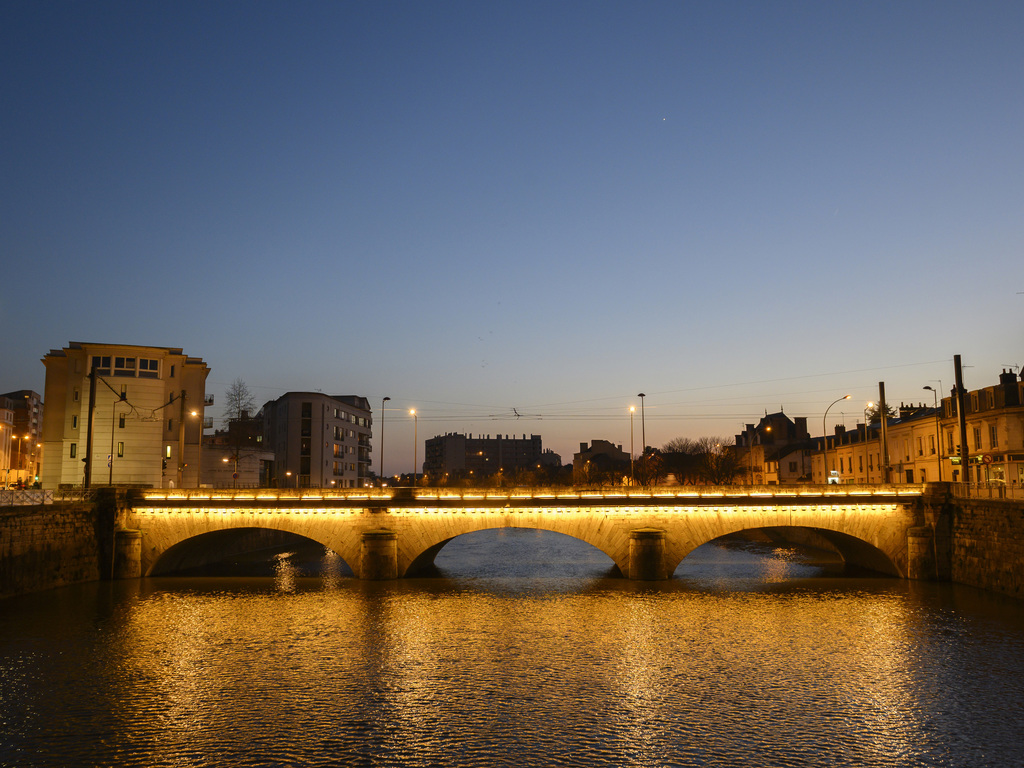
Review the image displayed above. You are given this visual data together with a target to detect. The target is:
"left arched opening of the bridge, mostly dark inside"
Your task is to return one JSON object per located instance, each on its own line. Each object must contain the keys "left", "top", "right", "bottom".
{"left": 148, "top": 528, "right": 353, "bottom": 578}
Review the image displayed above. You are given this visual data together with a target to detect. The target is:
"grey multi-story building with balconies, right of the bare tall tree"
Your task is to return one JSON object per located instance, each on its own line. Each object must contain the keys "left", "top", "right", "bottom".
{"left": 263, "top": 392, "right": 373, "bottom": 488}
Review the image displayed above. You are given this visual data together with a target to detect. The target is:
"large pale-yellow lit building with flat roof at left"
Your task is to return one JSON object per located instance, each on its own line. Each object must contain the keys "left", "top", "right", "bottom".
{"left": 41, "top": 342, "right": 210, "bottom": 488}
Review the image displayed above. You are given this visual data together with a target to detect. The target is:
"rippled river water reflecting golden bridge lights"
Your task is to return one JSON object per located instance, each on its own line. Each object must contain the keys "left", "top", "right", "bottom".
{"left": 0, "top": 530, "right": 1024, "bottom": 766}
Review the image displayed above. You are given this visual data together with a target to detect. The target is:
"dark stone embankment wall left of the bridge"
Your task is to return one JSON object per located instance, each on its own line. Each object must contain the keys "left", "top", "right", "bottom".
{"left": 0, "top": 500, "right": 114, "bottom": 598}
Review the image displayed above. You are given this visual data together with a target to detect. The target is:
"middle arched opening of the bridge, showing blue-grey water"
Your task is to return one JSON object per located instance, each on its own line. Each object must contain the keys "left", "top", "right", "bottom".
{"left": 407, "top": 527, "right": 622, "bottom": 579}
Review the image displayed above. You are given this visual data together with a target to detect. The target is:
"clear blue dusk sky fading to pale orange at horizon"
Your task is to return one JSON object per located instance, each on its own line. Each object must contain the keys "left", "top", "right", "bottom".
{"left": 0, "top": 1, "right": 1024, "bottom": 471}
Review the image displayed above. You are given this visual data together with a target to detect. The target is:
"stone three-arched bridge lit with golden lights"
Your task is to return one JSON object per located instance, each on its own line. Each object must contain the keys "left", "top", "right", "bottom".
{"left": 117, "top": 483, "right": 946, "bottom": 580}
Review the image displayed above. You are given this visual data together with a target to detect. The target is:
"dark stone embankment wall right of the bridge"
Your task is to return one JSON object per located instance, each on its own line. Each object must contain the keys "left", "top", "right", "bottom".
{"left": 947, "top": 499, "right": 1024, "bottom": 598}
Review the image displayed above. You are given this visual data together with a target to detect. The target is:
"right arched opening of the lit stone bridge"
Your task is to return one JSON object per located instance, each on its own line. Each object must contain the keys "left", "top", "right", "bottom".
{"left": 673, "top": 526, "right": 900, "bottom": 583}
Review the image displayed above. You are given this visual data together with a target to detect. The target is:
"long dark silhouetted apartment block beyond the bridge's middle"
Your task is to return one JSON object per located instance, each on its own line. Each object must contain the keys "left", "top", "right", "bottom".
{"left": 423, "top": 432, "right": 561, "bottom": 481}
